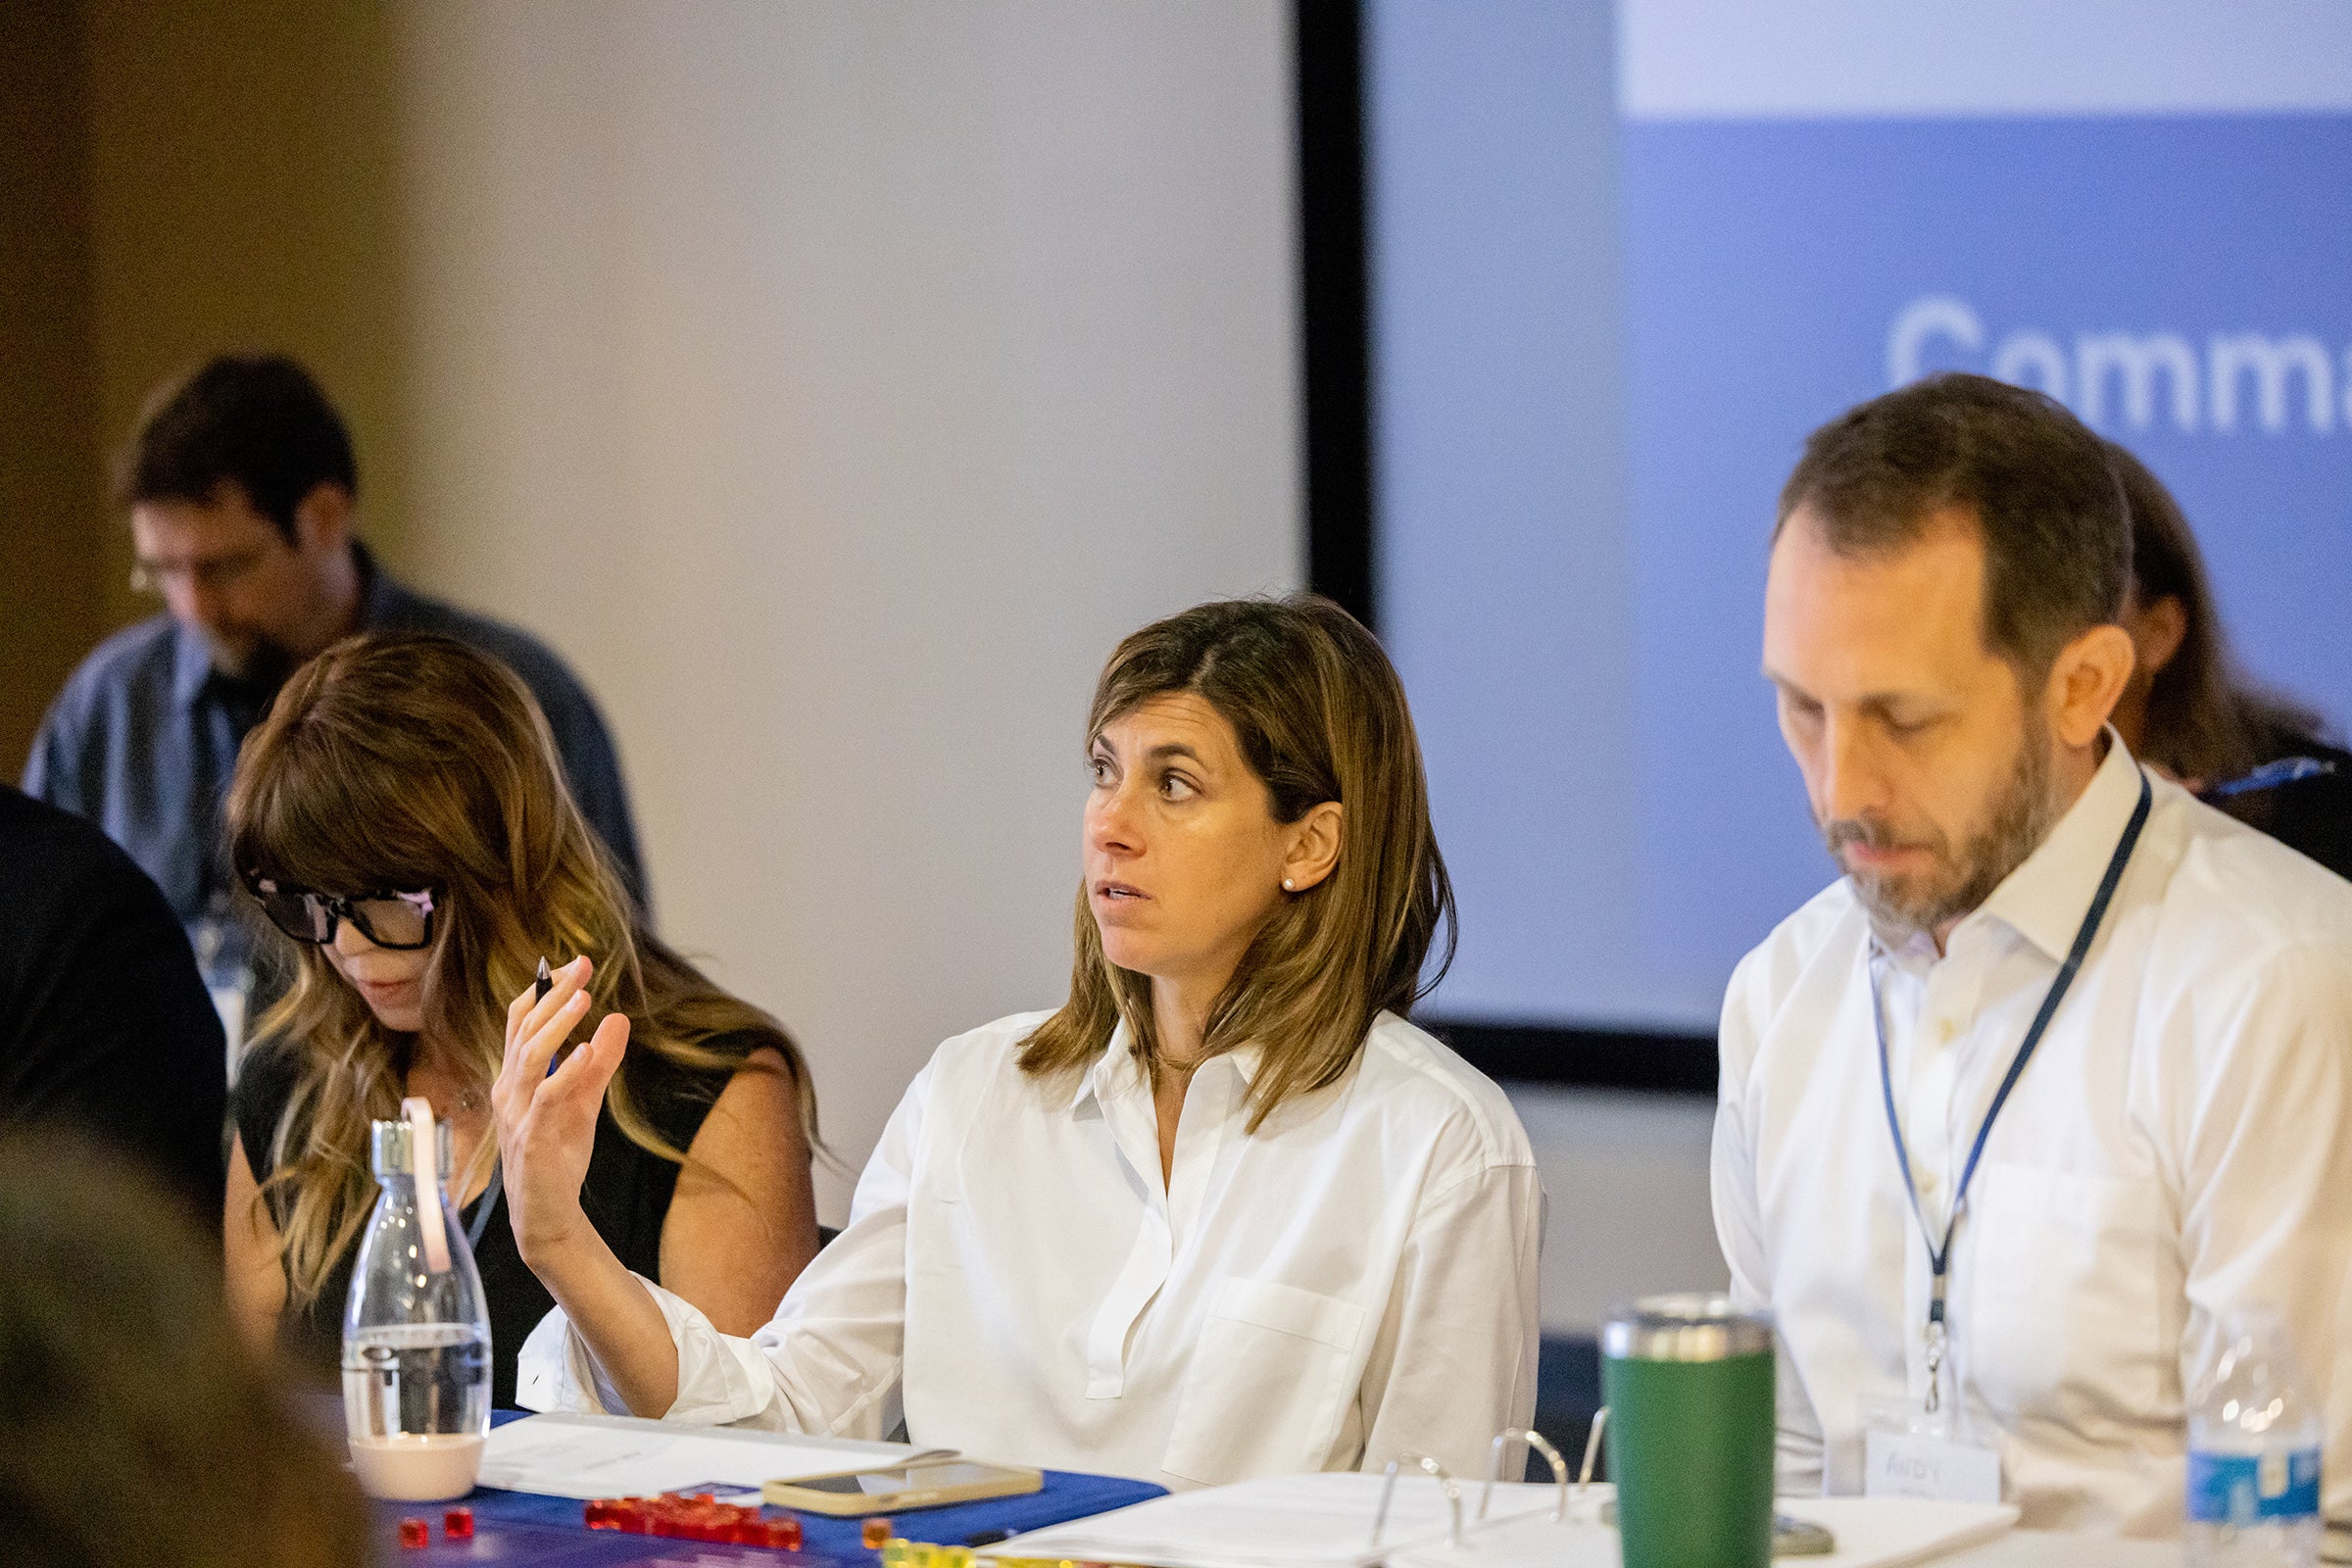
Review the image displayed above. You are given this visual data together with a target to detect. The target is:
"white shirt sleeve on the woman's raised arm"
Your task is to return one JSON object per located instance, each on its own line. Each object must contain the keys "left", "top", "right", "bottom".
{"left": 515, "top": 1069, "right": 931, "bottom": 1439}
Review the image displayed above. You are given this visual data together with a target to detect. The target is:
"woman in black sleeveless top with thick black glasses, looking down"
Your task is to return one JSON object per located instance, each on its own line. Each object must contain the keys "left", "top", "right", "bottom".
{"left": 225, "top": 635, "right": 816, "bottom": 1405}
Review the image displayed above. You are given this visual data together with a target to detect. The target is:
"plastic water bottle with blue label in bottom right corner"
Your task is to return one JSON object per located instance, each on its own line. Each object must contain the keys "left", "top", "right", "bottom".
{"left": 2187, "top": 1312, "right": 2324, "bottom": 1568}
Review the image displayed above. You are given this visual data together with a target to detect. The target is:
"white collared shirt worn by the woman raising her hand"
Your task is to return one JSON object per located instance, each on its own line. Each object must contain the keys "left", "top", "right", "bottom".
{"left": 519, "top": 1013, "right": 1543, "bottom": 1486}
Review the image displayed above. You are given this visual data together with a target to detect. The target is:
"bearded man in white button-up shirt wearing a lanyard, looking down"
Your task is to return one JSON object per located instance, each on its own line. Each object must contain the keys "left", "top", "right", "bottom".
{"left": 1715, "top": 376, "right": 2352, "bottom": 1535}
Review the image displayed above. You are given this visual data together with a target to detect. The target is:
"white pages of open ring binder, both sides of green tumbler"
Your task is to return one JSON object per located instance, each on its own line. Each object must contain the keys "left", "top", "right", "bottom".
{"left": 1004, "top": 1474, "right": 2018, "bottom": 1568}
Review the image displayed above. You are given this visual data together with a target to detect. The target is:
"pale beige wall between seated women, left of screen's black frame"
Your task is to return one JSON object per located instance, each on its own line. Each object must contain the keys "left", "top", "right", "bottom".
{"left": 398, "top": 0, "right": 1303, "bottom": 1220}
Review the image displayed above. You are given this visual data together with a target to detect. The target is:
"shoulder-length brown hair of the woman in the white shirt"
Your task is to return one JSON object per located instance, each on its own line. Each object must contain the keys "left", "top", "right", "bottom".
{"left": 1021, "top": 595, "right": 1453, "bottom": 1131}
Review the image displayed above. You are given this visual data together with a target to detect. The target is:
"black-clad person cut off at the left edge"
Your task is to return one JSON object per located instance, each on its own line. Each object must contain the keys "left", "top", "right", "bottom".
{"left": 0, "top": 785, "right": 225, "bottom": 1212}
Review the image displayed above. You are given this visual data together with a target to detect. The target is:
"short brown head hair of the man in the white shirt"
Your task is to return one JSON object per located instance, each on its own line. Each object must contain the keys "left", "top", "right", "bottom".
{"left": 1774, "top": 373, "right": 2131, "bottom": 682}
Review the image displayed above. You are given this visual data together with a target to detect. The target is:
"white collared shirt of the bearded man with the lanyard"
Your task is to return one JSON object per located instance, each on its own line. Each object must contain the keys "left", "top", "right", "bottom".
{"left": 1715, "top": 731, "right": 2352, "bottom": 1535}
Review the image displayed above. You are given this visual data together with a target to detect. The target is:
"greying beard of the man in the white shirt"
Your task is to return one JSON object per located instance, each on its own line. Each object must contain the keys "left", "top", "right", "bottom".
{"left": 1821, "top": 719, "right": 2058, "bottom": 948}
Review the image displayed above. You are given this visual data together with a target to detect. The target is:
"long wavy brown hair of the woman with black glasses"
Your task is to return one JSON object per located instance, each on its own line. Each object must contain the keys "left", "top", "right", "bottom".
{"left": 228, "top": 632, "right": 816, "bottom": 1304}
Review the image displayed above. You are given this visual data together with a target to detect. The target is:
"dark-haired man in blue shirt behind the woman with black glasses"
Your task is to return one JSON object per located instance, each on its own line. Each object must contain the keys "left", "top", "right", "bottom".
{"left": 24, "top": 355, "right": 645, "bottom": 1032}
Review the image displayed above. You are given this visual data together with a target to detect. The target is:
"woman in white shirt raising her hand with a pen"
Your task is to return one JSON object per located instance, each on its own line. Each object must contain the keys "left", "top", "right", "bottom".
{"left": 494, "top": 597, "right": 1543, "bottom": 1486}
